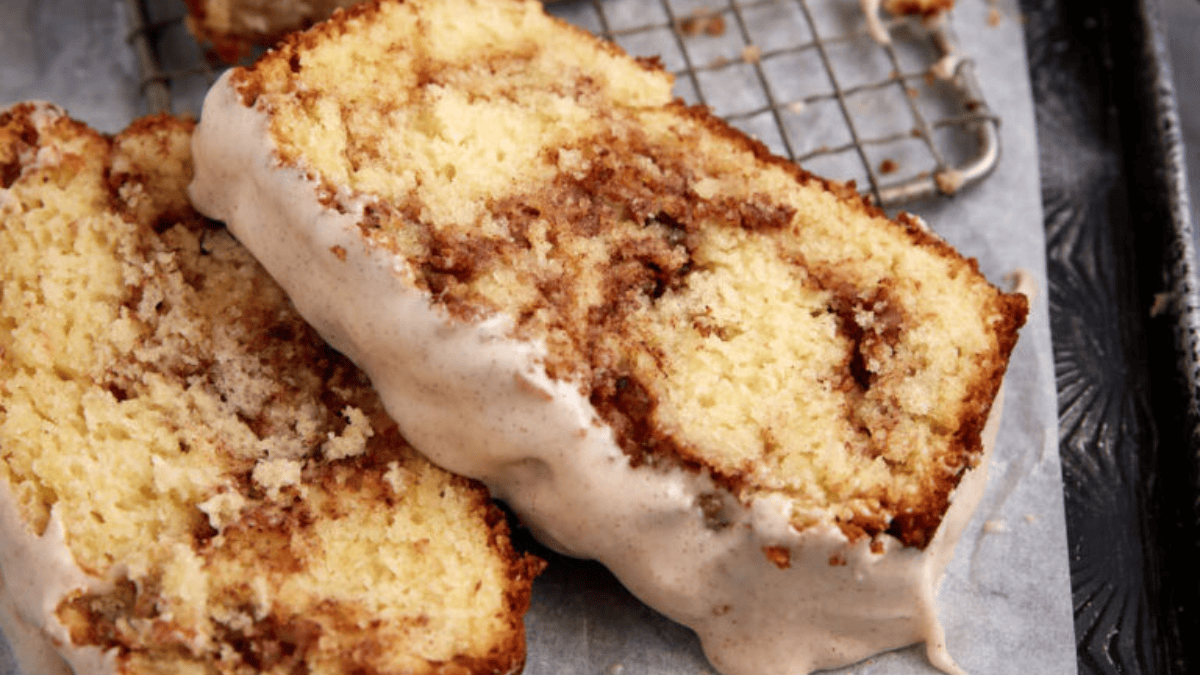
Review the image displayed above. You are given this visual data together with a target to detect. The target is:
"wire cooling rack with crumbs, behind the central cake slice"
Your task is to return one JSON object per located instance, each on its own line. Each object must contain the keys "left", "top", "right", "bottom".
{"left": 126, "top": 0, "right": 1000, "bottom": 207}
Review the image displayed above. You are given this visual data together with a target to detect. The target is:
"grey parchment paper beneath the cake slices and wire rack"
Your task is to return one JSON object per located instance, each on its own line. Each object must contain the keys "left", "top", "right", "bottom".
{"left": 0, "top": 0, "right": 1076, "bottom": 675}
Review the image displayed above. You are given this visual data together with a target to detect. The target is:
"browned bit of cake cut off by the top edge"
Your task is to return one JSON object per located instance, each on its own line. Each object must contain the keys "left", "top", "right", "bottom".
{"left": 186, "top": 0, "right": 359, "bottom": 61}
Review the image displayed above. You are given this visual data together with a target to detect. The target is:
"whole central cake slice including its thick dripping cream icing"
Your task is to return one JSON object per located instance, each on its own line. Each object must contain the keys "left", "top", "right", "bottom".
{"left": 184, "top": 0, "right": 1026, "bottom": 675}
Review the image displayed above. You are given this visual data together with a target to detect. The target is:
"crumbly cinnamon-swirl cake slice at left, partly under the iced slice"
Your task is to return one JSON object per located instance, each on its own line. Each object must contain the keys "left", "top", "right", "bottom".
{"left": 0, "top": 103, "right": 539, "bottom": 675}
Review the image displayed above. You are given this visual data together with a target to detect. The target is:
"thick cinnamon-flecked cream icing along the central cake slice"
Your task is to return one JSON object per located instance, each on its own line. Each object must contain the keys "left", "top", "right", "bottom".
{"left": 190, "top": 68, "right": 1000, "bottom": 675}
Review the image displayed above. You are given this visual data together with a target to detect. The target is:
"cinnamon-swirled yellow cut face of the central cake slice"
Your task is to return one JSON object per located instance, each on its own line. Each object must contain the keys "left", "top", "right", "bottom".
{"left": 233, "top": 0, "right": 1026, "bottom": 548}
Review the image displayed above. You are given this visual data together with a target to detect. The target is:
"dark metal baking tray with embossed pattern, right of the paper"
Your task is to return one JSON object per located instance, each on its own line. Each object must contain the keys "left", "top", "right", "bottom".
{"left": 1021, "top": 0, "right": 1200, "bottom": 674}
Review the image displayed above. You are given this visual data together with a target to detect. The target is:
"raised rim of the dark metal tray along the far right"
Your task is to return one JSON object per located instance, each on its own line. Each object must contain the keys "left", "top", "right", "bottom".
{"left": 1134, "top": 0, "right": 1200, "bottom": 673}
